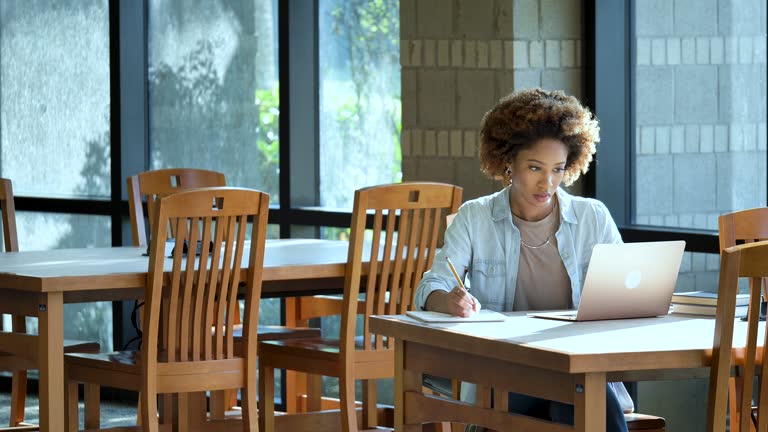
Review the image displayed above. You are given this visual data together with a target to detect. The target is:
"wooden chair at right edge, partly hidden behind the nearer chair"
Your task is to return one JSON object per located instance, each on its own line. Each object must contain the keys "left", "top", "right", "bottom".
{"left": 718, "top": 207, "right": 768, "bottom": 431}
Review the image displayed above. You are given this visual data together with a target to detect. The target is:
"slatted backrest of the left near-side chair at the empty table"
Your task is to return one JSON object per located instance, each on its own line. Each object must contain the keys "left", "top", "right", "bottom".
{"left": 142, "top": 188, "right": 269, "bottom": 374}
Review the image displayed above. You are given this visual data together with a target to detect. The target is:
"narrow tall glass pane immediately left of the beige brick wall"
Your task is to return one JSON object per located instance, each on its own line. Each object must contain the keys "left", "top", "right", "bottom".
{"left": 319, "top": 0, "right": 402, "bottom": 208}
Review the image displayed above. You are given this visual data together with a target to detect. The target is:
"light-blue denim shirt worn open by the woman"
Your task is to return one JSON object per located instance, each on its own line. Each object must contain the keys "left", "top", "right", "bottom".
{"left": 415, "top": 188, "right": 621, "bottom": 312}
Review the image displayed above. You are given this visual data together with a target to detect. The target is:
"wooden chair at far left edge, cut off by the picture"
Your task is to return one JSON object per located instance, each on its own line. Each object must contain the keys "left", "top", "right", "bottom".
{"left": 0, "top": 179, "right": 100, "bottom": 427}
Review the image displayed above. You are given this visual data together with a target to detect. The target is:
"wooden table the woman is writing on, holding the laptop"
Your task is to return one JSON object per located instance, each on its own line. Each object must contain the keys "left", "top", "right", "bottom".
{"left": 371, "top": 314, "right": 746, "bottom": 432}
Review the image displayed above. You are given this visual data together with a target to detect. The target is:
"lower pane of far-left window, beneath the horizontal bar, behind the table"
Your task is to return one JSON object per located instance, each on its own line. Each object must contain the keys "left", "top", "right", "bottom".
{"left": 7, "top": 212, "right": 112, "bottom": 351}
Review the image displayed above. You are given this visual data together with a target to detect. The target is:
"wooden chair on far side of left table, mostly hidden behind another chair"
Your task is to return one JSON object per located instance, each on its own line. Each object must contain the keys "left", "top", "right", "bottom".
{"left": 127, "top": 168, "right": 320, "bottom": 418}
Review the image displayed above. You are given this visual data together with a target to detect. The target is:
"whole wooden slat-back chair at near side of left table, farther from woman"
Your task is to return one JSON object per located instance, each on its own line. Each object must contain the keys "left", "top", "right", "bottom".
{"left": 65, "top": 188, "right": 269, "bottom": 431}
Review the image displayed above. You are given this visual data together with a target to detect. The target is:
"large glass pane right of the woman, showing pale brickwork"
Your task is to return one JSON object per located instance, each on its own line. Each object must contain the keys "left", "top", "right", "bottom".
{"left": 633, "top": 0, "right": 768, "bottom": 230}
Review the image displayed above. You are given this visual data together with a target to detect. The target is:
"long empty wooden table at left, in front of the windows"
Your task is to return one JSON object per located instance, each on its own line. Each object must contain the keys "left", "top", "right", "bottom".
{"left": 0, "top": 239, "right": 348, "bottom": 432}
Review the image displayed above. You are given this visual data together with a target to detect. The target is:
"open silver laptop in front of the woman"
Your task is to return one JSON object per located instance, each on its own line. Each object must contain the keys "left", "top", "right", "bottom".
{"left": 528, "top": 240, "right": 685, "bottom": 321}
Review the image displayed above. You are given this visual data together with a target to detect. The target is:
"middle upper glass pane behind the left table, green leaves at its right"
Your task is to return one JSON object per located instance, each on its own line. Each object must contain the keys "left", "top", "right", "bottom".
{"left": 148, "top": 0, "right": 280, "bottom": 204}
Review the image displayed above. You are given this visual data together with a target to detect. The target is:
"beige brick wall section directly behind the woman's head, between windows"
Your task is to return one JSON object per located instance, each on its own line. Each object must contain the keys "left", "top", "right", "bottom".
{"left": 400, "top": 0, "right": 582, "bottom": 200}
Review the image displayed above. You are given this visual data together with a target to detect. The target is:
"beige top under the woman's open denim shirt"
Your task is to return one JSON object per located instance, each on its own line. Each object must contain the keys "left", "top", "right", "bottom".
{"left": 512, "top": 207, "right": 572, "bottom": 311}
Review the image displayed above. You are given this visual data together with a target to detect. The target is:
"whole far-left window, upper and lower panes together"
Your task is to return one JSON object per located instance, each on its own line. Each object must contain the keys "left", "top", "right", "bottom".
{"left": 0, "top": 0, "right": 112, "bottom": 350}
